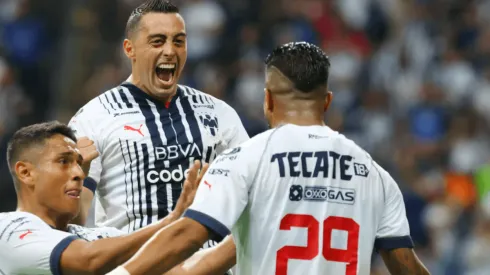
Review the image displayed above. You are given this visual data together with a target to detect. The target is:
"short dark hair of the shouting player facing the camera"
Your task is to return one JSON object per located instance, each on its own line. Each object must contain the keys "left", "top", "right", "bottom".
{"left": 126, "top": 0, "right": 179, "bottom": 37}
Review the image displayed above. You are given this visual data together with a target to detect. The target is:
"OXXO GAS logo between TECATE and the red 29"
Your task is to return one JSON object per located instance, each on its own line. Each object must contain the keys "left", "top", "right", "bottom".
{"left": 289, "top": 185, "right": 356, "bottom": 205}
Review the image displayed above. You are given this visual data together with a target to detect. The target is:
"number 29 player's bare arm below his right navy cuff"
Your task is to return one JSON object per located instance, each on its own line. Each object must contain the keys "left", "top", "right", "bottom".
{"left": 379, "top": 248, "right": 430, "bottom": 275}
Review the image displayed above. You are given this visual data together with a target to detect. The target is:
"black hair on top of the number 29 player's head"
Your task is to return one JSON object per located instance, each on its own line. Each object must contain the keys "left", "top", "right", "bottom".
{"left": 265, "top": 42, "right": 330, "bottom": 93}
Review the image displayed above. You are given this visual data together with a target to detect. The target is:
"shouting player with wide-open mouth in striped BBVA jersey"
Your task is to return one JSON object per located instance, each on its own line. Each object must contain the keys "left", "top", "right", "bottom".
{"left": 69, "top": 0, "right": 248, "bottom": 235}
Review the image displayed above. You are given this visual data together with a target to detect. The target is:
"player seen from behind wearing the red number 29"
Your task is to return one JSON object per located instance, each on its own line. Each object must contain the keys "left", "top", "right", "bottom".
{"left": 110, "top": 43, "right": 429, "bottom": 275}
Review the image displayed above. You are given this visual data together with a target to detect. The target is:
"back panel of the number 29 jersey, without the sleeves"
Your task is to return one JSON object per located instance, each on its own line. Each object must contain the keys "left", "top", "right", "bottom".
{"left": 233, "top": 125, "right": 408, "bottom": 275}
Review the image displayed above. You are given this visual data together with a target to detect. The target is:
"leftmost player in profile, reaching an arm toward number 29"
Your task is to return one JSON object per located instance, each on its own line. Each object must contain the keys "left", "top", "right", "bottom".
{"left": 0, "top": 122, "right": 234, "bottom": 275}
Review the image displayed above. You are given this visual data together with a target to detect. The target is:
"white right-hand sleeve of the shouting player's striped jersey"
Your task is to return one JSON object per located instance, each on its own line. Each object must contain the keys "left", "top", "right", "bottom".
{"left": 221, "top": 102, "right": 249, "bottom": 149}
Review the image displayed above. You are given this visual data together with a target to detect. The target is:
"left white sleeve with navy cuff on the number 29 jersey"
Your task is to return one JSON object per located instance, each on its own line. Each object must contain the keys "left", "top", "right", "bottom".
{"left": 184, "top": 147, "right": 256, "bottom": 241}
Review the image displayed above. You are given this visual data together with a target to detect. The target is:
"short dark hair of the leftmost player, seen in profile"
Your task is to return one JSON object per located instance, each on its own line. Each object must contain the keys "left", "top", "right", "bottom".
{"left": 7, "top": 121, "right": 77, "bottom": 181}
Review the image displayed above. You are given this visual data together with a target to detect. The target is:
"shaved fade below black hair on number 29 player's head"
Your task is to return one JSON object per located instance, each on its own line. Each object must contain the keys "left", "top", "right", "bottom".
{"left": 265, "top": 66, "right": 328, "bottom": 101}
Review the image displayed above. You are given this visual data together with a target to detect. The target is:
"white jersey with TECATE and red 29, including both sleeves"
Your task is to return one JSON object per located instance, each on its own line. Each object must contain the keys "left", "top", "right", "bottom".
{"left": 185, "top": 125, "right": 413, "bottom": 275}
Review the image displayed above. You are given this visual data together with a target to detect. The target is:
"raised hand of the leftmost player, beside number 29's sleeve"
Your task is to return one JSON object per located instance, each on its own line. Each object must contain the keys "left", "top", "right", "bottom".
{"left": 174, "top": 160, "right": 209, "bottom": 217}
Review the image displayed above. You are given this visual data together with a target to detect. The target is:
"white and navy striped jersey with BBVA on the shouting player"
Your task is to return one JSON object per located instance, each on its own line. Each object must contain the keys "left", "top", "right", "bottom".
{"left": 69, "top": 82, "right": 249, "bottom": 232}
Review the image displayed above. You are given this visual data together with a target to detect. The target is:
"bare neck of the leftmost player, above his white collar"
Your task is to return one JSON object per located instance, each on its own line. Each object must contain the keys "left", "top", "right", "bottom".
{"left": 16, "top": 197, "right": 72, "bottom": 231}
